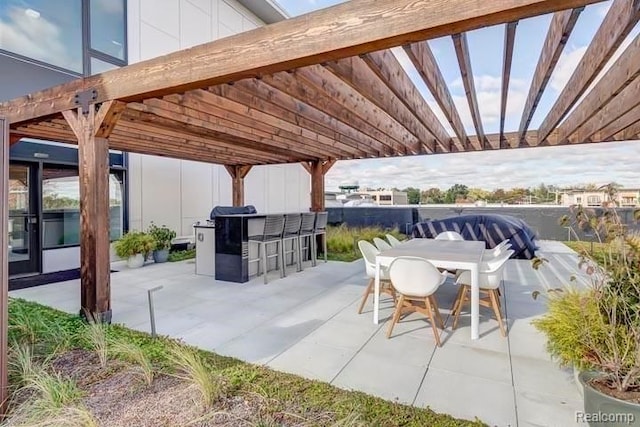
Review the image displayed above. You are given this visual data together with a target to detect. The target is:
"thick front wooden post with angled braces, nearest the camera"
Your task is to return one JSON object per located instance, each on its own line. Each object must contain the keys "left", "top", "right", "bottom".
{"left": 62, "top": 101, "right": 124, "bottom": 323}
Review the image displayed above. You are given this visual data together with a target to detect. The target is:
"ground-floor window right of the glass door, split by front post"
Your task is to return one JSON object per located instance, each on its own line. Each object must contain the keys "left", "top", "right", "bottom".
{"left": 42, "top": 165, "right": 123, "bottom": 249}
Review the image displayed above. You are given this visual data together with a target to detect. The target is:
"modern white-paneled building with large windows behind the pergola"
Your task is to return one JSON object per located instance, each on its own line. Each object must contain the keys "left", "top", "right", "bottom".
{"left": 0, "top": 0, "right": 310, "bottom": 274}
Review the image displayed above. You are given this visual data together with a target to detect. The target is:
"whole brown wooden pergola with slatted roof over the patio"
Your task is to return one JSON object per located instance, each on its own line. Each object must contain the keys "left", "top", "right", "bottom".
{"left": 0, "top": 0, "right": 640, "bottom": 412}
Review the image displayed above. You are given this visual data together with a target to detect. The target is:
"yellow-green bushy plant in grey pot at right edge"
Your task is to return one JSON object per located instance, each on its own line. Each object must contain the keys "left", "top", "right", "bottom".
{"left": 533, "top": 187, "right": 640, "bottom": 426}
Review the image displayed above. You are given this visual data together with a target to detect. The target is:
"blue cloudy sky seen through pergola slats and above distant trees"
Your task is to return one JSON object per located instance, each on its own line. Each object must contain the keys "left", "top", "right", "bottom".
{"left": 277, "top": 0, "right": 640, "bottom": 190}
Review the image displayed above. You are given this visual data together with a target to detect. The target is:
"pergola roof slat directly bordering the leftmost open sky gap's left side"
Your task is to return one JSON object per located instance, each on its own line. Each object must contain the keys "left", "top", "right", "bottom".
{"left": 362, "top": 50, "right": 461, "bottom": 152}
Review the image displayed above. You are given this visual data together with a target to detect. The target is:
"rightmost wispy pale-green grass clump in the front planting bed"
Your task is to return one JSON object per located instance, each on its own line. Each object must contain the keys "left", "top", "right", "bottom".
{"left": 169, "top": 345, "right": 225, "bottom": 408}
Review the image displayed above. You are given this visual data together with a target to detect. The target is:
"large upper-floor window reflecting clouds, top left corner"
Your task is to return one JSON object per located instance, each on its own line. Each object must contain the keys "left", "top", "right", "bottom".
{"left": 0, "top": 0, "right": 82, "bottom": 73}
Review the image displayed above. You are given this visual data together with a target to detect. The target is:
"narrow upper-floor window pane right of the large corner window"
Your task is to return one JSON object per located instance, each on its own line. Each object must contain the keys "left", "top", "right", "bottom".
{"left": 89, "top": 0, "right": 125, "bottom": 60}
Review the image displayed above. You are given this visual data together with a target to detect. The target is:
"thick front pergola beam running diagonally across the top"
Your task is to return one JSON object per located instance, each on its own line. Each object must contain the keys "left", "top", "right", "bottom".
{"left": 0, "top": 0, "right": 597, "bottom": 123}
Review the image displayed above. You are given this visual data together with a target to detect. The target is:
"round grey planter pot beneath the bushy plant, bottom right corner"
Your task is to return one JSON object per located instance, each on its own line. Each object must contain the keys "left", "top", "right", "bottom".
{"left": 577, "top": 372, "right": 640, "bottom": 427}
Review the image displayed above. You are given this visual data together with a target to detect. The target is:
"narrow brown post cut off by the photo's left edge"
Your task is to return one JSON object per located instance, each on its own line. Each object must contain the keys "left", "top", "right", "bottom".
{"left": 0, "top": 117, "right": 10, "bottom": 416}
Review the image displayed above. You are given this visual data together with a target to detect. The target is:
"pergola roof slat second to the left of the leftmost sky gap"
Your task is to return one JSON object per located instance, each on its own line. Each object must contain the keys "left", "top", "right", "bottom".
{"left": 324, "top": 56, "right": 437, "bottom": 153}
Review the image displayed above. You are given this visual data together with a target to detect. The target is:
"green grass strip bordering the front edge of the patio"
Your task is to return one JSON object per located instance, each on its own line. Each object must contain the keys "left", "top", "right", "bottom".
{"left": 3, "top": 298, "right": 484, "bottom": 426}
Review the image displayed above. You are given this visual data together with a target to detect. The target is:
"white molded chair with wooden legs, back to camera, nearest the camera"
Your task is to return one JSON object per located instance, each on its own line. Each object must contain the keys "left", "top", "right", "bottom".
{"left": 387, "top": 257, "right": 447, "bottom": 347}
